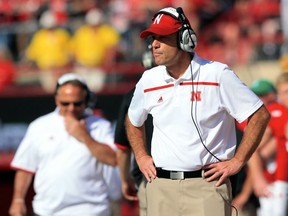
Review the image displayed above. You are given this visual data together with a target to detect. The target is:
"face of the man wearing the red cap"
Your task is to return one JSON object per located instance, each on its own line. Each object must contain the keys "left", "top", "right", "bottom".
{"left": 152, "top": 33, "right": 179, "bottom": 67}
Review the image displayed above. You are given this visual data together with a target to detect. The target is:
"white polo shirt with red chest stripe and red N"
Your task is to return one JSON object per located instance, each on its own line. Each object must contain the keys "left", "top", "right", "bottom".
{"left": 128, "top": 53, "right": 263, "bottom": 171}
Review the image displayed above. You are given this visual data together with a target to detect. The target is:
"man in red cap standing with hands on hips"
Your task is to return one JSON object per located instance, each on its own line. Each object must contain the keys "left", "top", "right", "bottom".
{"left": 126, "top": 8, "right": 270, "bottom": 216}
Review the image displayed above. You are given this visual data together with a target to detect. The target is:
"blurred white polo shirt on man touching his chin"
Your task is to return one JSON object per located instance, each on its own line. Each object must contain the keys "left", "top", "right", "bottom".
{"left": 11, "top": 110, "right": 121, "bottom": 216}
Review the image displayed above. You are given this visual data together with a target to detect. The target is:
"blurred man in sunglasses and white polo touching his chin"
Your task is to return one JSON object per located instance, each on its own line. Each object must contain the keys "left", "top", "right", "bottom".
{"left": 9, "top": 74, "right": 121, "bottom": 216}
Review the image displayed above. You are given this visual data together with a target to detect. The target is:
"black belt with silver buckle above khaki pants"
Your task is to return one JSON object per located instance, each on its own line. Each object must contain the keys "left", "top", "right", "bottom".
{"left": 156, "top": 168, "right": 202, "bottom": 180}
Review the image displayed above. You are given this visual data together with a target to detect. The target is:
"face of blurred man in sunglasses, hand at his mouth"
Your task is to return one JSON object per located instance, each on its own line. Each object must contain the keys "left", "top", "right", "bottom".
{"left": 55, "top": 83, "right": 87, "bottom": 119}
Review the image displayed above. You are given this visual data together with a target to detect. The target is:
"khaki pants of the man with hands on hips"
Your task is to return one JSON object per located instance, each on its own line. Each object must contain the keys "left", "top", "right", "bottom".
{"left": 146, "top": 178, "right": 232, "bottom": 216}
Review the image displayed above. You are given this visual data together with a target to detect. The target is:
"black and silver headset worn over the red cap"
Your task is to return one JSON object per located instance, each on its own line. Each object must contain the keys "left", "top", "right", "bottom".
{"left": 152, "top": 7, "right": 197, "bottom": 53}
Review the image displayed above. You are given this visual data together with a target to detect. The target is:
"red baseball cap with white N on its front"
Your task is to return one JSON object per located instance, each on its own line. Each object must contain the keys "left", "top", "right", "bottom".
{"left": 140, "top": 13, "right": 182, "bottom": 38}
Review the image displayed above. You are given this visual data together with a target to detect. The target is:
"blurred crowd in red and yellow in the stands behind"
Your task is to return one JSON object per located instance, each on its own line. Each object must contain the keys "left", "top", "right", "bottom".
{"left": 0, "top": 0, "right": 283, "bottom": 91}
